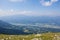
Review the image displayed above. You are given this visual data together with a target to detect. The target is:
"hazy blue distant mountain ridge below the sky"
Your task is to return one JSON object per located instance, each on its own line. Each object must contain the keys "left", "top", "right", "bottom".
{"left": 0, "top": 15, "right": 60, "bottom": 25}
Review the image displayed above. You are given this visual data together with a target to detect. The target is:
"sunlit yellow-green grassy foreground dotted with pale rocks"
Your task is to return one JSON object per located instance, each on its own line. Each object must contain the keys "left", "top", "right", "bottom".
{"left": 0, "top": 33, "right": 60, "bottom": 40}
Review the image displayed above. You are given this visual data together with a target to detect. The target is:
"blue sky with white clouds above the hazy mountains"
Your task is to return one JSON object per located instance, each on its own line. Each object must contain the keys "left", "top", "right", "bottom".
{"left": 0, "top": 0, "right": 60, "bottom": 17}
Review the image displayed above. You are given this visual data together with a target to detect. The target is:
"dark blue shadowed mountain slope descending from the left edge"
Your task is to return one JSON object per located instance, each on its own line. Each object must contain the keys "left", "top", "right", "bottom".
{"left": 0, "top": 20, "right": 32, "bottom": 35}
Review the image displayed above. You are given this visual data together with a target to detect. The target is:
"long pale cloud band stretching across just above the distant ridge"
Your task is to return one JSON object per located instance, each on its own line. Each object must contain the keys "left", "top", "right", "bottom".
{"left": 0, "top": 9, "right": 60, "bottom": 17}
